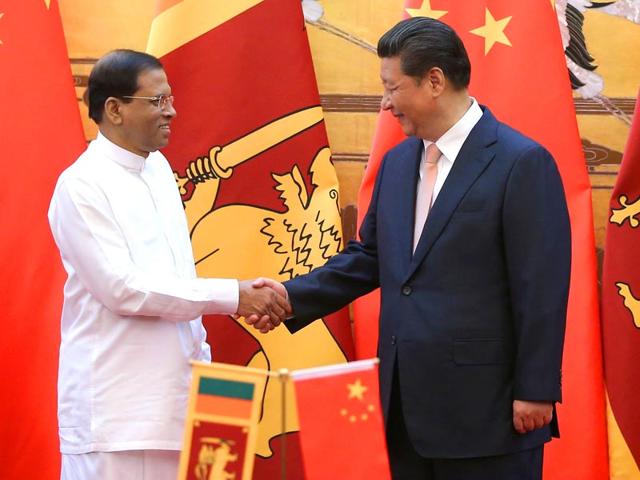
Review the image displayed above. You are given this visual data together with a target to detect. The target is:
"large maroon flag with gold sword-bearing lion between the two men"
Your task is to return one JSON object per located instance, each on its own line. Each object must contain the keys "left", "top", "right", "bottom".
{"left": 147, "top": 0, "right": 353, "bottom": 479}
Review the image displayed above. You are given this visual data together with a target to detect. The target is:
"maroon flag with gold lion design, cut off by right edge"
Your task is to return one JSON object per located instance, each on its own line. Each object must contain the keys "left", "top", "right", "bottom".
{"left": 602, "top": 89, "right": 640, "bottom": 480}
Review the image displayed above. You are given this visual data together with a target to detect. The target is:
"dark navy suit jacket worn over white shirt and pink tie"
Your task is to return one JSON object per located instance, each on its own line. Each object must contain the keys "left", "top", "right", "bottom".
{"left": 285, "top": 108, "right": 571, "bottom": 458}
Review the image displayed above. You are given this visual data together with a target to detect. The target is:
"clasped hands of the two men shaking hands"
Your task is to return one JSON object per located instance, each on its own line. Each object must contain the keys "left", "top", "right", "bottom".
{"left": 235, "top": 278, "right": 292, "bottom": 333}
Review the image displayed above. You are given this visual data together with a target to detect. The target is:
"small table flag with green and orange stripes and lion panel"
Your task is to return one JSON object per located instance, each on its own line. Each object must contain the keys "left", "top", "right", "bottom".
{"left": 178, "top": 362, "right": 268, "bottom": 480}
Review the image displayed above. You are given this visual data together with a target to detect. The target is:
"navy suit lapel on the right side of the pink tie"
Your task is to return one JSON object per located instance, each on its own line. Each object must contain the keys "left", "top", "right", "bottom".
{"left": 408, "top": 109, "right": 498, "bottom": 277}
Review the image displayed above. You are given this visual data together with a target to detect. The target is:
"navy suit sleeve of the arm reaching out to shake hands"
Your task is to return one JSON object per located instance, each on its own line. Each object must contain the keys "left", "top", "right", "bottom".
{"left": 284, "top": 155, "right": 387, "bottom": 332}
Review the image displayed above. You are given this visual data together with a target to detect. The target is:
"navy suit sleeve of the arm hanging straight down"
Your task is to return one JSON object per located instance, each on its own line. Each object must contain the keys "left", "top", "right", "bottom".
{"left": 503, "top": 146, "right": 571, "bottom": 401}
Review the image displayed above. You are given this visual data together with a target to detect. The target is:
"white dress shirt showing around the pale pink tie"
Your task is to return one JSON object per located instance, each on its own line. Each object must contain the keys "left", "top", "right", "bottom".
{"left": 418, "top": 98, "right": 482, "bottom": 205}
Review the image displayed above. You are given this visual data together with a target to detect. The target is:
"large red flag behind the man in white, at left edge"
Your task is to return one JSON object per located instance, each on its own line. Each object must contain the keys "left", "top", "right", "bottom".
{"left": 0, "top": 0, "right": 84, "bottom": 480}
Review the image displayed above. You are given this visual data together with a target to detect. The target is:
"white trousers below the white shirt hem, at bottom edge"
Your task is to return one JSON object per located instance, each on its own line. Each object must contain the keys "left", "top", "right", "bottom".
{"left": 60, "top": 450, "right": 180, "bottom": 480}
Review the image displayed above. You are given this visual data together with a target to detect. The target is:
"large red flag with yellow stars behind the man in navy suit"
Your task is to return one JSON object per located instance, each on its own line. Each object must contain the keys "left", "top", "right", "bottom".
{"left": 354, "top": 0, "right": 608, "bottom": 480}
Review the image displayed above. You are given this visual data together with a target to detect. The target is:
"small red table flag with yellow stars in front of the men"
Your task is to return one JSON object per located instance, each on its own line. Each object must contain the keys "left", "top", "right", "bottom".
{"left": 291, "top": 359, "right": 391, "bottom": 480}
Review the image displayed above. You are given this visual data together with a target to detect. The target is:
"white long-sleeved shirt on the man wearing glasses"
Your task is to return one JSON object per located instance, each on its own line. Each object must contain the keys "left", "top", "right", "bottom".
{"left": 49, "top": 135, "right": 238, "bottom": 453}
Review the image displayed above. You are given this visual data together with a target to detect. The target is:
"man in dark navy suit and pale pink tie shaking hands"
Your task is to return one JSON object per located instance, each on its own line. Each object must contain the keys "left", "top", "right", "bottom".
{"left": 249, "top": 18, "right": 571, "bottom": 480}
